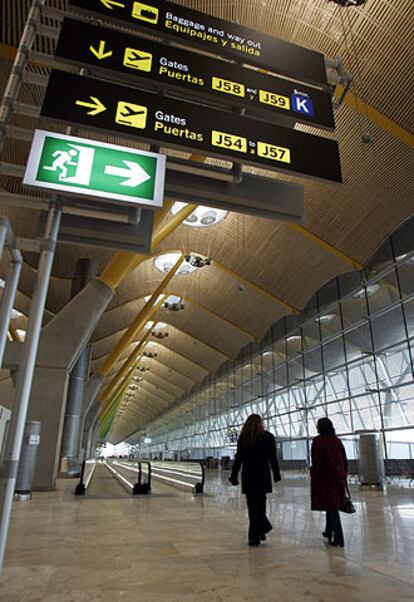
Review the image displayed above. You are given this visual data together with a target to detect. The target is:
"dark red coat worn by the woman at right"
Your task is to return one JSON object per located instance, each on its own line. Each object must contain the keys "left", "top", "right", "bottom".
{"left": 310, "top": 435, "right": 347, "bottom": 510}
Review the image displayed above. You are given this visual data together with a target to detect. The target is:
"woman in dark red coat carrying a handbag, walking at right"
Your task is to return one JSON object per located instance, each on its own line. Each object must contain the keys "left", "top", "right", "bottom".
{"left": 310, "top": 418, "right": 348, "bottom": 548}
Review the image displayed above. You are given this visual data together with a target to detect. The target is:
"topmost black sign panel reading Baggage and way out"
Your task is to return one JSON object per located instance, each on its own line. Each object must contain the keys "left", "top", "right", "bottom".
{"left": 68, "top": 0, "right": 327, "bottom": 85}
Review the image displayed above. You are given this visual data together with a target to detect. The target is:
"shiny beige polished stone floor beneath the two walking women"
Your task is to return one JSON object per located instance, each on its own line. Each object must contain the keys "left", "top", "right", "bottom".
{"left": 0, "top": 473, "right": 414, "bottom": 602}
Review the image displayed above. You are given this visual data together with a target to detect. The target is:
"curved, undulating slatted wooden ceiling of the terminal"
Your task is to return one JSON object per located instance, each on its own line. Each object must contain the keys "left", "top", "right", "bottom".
{"left": 0, "top": 0, "right": 414, "bottom": 439}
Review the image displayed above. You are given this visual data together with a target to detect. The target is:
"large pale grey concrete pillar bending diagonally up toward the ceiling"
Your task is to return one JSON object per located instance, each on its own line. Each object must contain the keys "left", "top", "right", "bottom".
{"left": 0, "top": 260, "right": 114, "bottom": 491}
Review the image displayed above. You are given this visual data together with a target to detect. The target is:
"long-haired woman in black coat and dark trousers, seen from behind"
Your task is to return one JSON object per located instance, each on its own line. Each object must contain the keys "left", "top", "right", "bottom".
{"left": 229, "top": 414, "right": 281, "bottom": 546}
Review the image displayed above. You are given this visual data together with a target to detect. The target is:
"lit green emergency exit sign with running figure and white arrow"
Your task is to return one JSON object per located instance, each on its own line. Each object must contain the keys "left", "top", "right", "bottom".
{"left": 23, "top": 129, "right": 165, "bottom": 207}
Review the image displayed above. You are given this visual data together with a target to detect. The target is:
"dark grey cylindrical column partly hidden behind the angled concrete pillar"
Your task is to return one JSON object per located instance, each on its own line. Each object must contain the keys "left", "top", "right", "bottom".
{"left": 60, "top": 259, "right": 96, "bottom": 477}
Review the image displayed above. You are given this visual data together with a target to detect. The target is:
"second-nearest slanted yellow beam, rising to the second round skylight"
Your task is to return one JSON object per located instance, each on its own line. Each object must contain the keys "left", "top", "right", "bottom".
{"left": 98, "top": 255, "right": 184, "bottom": 376}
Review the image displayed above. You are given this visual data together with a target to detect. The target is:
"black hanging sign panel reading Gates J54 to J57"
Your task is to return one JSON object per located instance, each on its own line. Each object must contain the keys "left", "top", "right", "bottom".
{"left": 41, "top": 71, "right": 341, "bottom": 182}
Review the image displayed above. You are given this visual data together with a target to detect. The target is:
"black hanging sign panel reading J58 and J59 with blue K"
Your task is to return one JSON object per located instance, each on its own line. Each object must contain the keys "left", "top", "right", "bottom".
{"left": 56, "top": 19, "right": 335, "bottom": 129}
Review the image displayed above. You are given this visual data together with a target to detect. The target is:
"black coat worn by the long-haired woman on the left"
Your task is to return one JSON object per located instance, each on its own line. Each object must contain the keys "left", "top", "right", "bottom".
{"left": 230, "top": 431, "right": 281, "bottom": 495}
